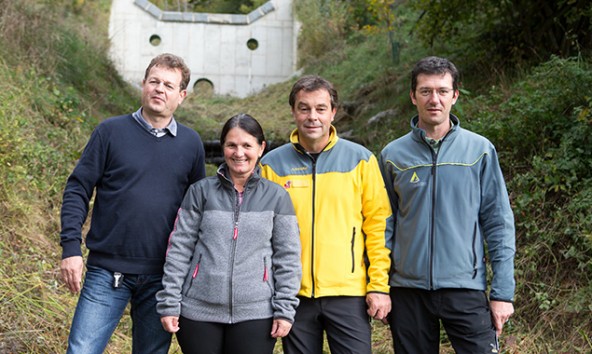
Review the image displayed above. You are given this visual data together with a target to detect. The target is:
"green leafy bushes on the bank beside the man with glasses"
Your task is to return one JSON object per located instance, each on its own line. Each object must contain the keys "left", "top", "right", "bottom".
{"left": 464, "top": 58, "right": 592, "bottom": 352}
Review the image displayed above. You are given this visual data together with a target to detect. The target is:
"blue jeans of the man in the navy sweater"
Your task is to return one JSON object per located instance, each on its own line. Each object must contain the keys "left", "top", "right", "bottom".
{"left": 67, "top": 266, "right": 171, "bottom": 354}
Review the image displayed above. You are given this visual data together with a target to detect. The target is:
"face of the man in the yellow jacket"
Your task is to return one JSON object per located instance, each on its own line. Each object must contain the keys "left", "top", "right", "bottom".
{"left": 292, "top": 89, "right": 337, "bottom": 152}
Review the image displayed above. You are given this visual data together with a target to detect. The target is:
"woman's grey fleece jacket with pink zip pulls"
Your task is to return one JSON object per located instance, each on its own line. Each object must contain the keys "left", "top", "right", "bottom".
{"left": 156, "top": 164, "right": 302, "bottom": 323}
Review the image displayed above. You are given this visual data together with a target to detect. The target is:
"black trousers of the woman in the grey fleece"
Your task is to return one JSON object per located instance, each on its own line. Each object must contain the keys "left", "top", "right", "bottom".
{"left": 177, "top": 316, "right": 276, "bottom": 354}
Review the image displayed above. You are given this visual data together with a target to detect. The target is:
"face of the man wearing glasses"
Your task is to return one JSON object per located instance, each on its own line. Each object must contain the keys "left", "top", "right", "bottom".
{"left": 410, "top": 73, "right": 459, "bottom": 129}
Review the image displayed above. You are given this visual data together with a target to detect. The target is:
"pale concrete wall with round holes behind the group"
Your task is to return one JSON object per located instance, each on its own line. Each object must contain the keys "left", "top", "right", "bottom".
{"left": 109, "top": 0, "right": 298, "bottom": 97}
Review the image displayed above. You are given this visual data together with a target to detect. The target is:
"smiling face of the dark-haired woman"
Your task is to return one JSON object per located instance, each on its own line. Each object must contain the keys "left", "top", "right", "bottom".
{"left": 223, "top": 127, "right": 265, "bottom": 180}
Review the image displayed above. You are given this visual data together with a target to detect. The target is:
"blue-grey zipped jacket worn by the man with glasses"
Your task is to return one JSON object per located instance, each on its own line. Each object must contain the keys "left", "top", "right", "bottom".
{"left": 380, "top": 115, "right": 515, "bottom": 301}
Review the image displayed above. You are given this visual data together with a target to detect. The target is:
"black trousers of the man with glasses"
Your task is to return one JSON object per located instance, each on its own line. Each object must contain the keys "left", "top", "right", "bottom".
{"left": 389, "top": 288, "right": 499, "bottom": 354}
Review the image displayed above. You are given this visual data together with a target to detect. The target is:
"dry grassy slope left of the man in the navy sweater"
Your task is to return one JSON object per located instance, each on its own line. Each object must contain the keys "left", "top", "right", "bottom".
{"left": 0, "top": 0, "right": 137, "bottom": 353}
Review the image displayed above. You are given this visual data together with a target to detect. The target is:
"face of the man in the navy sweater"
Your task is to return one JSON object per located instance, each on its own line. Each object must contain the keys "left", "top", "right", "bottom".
{"left": 142, "top": 66, "right": 187, "bottom": 120}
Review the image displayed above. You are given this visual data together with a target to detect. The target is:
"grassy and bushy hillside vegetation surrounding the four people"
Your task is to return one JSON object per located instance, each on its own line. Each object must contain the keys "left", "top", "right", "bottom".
{"left": 0, "top": 0, "right": 592, "bottom": 353}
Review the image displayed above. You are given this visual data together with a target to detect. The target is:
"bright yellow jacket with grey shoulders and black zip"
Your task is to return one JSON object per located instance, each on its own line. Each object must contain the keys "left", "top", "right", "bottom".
{"left": 261, "top": 127, "right": 394, "bottom": 297}
